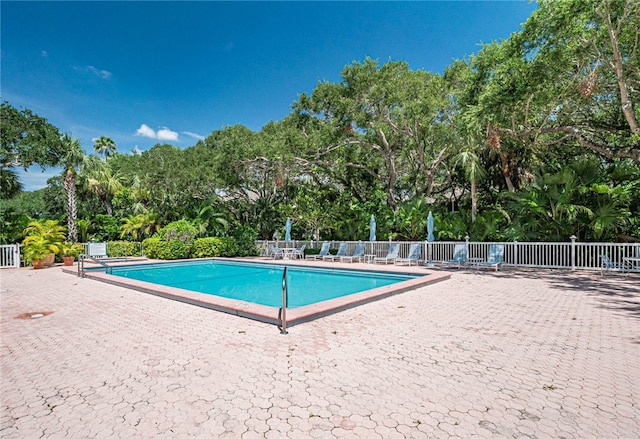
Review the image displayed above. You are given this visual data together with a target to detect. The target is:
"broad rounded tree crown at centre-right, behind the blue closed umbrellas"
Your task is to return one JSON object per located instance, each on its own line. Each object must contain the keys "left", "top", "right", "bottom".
{"left": 294, "top": 58, "right": 452, "bottom": 208}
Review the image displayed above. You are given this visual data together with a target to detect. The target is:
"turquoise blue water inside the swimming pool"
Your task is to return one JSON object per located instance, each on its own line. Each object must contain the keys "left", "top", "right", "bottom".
{"left": 107, "top": 261, "right": 417, "bottom": 308}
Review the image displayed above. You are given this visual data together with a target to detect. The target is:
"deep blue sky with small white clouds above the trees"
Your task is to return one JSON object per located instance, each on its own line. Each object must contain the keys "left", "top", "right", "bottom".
{"left": 0, "top": 0, "right": 536, "bottom": 190}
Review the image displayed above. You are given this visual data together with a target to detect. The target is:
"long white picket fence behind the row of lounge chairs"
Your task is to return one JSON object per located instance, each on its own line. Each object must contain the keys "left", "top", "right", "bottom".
{"left": 256, "top": 239, "right": 640, "bottom": 270}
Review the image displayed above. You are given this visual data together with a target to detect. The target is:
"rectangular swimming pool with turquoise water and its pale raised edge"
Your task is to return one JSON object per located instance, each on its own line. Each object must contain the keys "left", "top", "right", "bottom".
{"left": 80, "top": 258, "right": 450, "bottom": 326}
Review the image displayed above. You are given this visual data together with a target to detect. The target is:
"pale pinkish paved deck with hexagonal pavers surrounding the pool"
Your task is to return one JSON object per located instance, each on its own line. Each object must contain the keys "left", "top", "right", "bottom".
{"left": 0, "top": 262, "right": 640, "bottom": 439}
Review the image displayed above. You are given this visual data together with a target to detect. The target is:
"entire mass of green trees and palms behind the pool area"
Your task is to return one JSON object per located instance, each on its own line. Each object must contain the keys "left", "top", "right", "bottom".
{"left": 0, "top": 0, "right": 640, "bottom": 244}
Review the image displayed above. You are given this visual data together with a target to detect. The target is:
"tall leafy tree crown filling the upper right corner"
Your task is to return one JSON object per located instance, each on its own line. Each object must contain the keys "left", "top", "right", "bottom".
{"left": 465, "top": 0, "right": 640, "bottom": 167}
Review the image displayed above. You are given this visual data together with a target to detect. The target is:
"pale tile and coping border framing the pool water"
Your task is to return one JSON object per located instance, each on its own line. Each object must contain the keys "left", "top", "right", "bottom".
{"left": 64, "top": 258, "right": 451, "bottom": 326}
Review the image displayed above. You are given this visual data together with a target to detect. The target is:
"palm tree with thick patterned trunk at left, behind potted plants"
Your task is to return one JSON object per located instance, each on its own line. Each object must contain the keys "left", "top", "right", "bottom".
{"left": 60, "top": 134, "right": 84, "bottom": 242}
